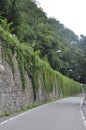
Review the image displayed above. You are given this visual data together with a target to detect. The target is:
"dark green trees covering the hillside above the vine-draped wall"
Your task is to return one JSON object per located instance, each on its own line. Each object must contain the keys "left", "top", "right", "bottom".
{"left": 0, "top": 0, "right": 86, "bottom": 83}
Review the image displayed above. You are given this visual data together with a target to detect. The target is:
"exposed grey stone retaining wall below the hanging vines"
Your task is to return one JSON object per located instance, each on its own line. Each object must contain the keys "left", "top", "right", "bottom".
{"left": 0, "top": 41, "right": 59, "bottom": 113}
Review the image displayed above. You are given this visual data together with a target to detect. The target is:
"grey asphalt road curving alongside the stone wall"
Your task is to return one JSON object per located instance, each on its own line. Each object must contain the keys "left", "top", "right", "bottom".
{"left": 0, "top": 97, "right": 86, "bottom": 130}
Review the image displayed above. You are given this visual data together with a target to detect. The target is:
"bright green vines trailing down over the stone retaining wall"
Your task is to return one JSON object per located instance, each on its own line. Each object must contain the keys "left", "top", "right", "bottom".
{"left": 0, "top": 26, "right": 81, "bottom": 99}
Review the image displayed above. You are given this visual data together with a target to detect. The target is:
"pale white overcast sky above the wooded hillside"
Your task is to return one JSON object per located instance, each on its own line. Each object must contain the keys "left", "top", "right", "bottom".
{"left": 37, "top": 0, "right": 86, "bottom": 36}
